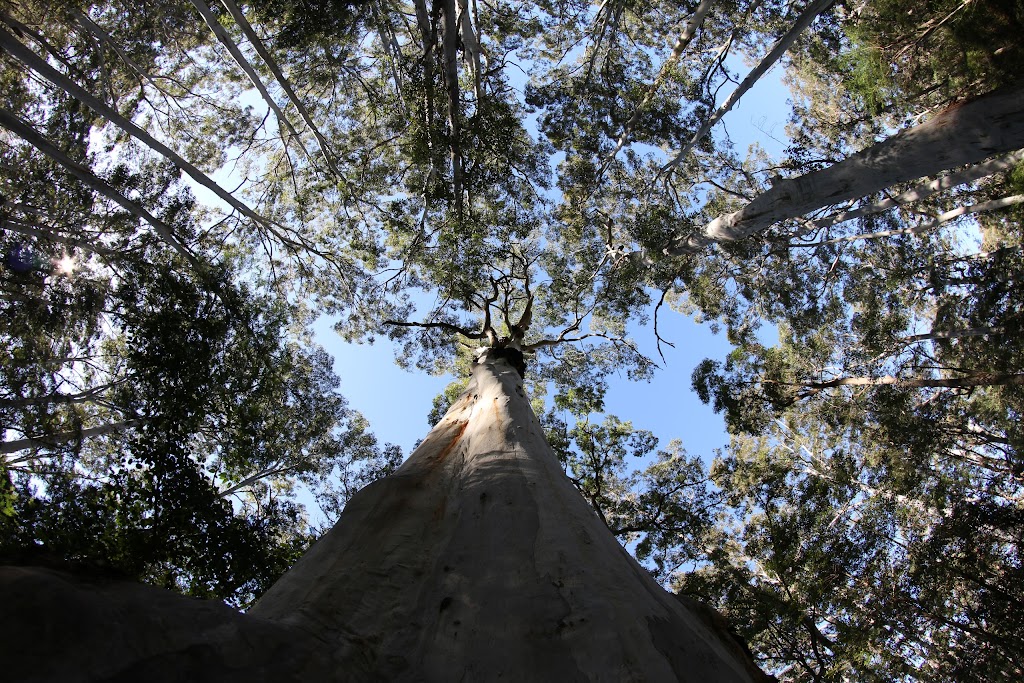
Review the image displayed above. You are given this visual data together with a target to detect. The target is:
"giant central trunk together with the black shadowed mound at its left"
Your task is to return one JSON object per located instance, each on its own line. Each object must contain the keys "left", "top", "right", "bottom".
{"left": 0, "top": 349, "right": 767, "bottom": 683}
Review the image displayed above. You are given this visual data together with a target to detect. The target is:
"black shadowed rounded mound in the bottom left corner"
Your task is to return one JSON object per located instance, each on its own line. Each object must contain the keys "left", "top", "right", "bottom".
{"left": 0, "top": 567, "right": 329, "bottom": 683}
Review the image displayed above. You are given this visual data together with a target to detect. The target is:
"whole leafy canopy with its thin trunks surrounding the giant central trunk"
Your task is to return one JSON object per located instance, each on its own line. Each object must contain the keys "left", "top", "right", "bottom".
{"left": 0, "top": 0, "right": 1024, "bottom": 681}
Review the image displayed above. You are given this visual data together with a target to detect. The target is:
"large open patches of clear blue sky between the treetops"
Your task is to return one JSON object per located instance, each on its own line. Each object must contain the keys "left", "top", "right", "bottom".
{"left": 315, "top": 59, "right": 790, "bottom": 459}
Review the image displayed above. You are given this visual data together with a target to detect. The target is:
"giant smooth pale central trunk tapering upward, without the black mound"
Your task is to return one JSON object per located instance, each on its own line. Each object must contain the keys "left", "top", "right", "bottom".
{"left": 250, "top": 351, "right": 762, "bottom": 681}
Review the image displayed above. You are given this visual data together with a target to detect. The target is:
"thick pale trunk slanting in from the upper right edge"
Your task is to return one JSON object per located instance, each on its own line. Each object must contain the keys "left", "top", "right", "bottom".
{"left": 665, "top": 80, "right": 1024, "bottom": 256}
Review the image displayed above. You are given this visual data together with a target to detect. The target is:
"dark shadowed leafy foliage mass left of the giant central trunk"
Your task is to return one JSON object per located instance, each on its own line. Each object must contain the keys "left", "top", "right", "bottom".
{"left": 0, "top": 246, "right": 391, "bottom": 604}
